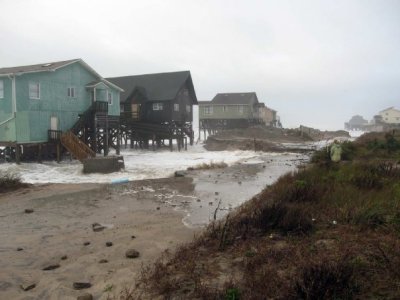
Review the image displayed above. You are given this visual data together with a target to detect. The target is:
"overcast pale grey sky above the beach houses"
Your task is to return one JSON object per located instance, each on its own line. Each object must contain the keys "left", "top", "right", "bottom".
{"left": 0, "top": 0, "right": 400, "bottom": 129}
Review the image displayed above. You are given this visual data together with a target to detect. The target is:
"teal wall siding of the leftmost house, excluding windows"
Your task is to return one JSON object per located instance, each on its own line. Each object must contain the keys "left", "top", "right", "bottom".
{"left": 0, "top": 62, "right": 120, "bottom": 143}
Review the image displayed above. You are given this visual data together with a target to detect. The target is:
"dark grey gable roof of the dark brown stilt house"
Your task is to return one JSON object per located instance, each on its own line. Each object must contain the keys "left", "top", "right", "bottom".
{"left": 106, "top": 71, "right": 197, "bottom": 104}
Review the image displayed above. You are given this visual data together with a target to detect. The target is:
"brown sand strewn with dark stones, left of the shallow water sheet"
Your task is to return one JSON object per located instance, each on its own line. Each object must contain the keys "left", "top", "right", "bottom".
{"left": 0, "top": 178, "right": 194, "bottom": 299}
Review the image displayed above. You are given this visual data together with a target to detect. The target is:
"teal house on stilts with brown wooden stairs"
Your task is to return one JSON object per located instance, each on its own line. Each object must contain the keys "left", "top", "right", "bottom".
{"left": 0, "top": 59, "right": 123, "bottom": 162}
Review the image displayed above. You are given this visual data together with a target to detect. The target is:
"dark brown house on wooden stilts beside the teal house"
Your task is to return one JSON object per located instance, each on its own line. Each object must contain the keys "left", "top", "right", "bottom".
{"left": 107, "top": 71, "right": 197, "bottom": 150}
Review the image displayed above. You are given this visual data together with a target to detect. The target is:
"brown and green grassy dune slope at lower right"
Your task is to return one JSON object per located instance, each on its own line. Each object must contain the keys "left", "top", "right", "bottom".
{"left": 130, "top": 132, "right": 400, "bottom": 300}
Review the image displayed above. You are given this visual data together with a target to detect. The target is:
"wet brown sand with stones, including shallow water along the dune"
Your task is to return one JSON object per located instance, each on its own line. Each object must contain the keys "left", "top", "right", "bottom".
{"left": 0, "top": 155, "right": 305, "bottom": 299}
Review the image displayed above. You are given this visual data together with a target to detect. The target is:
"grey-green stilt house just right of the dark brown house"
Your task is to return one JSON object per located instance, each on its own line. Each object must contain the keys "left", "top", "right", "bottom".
{"left": 199, "top": 92, "right": 276, "bottom": 129}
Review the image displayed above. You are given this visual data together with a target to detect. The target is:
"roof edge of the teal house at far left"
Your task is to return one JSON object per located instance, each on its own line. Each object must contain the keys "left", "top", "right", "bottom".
{"left": 0, "top": 58, "right": 123, "bottom": 92}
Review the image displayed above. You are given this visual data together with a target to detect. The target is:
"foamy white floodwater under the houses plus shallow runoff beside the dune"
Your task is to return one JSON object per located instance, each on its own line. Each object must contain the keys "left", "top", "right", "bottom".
{"left": 0, "top": 144, "right": 315, "bottom": 227}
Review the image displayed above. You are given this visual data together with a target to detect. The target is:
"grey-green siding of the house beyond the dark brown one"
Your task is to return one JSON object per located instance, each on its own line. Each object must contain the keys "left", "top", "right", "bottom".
{"left": 199, "top": 104, "right": 253, "bottom": 120}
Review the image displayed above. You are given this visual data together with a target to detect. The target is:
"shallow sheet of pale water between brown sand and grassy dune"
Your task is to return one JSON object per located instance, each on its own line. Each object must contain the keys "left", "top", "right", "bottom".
{"left": 183, "top": 153, "right": 308, "bottom": 227}
